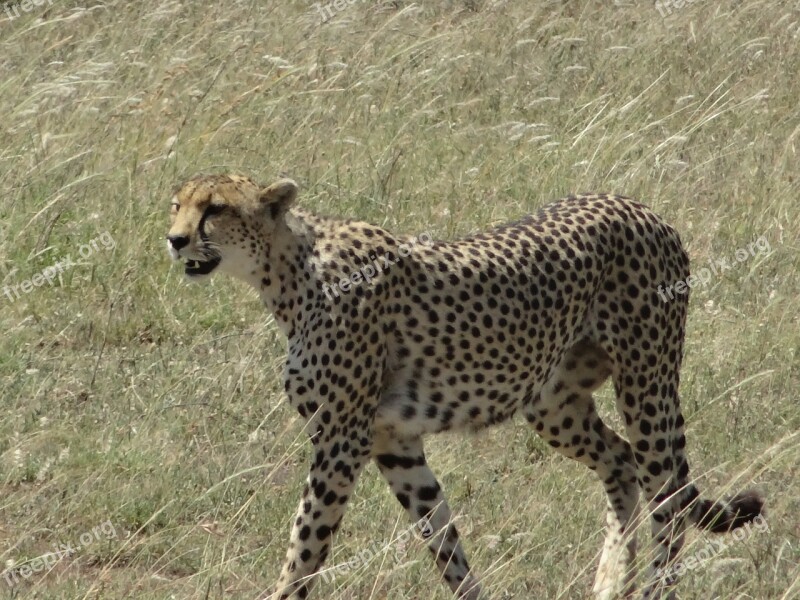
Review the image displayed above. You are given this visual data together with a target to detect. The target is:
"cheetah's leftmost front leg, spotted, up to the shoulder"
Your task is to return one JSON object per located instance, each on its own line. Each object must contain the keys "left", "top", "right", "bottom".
{"left": 268, "top": 332, "right": 383, "bottom": 600}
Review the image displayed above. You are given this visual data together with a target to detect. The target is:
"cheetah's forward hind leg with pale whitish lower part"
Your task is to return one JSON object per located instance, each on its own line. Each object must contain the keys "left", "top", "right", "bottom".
{"left": 524, "top": 340, "right": 639, "bottom": 600}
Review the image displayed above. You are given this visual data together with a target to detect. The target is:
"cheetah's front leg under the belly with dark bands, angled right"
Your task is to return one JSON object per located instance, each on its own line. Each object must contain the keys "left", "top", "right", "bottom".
{"left": 372, "top": 430, "right": 481, "bottom": 600}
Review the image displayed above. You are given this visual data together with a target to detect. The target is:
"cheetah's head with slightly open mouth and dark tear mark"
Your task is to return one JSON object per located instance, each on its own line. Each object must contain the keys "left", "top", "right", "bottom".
{"left": 167, "top": 175, "right": 297, "bottom": 279}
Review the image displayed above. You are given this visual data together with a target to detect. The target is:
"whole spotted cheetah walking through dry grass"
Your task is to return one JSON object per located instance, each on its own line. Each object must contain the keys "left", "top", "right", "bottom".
{"left": 167, "top": 175, "right": 763, "bottom": 600}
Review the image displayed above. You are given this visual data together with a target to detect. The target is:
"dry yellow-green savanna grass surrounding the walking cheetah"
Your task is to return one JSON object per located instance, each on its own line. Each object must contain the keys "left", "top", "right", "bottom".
{"left": 0, "top": 0, "right": 800, "bottom": 600}
